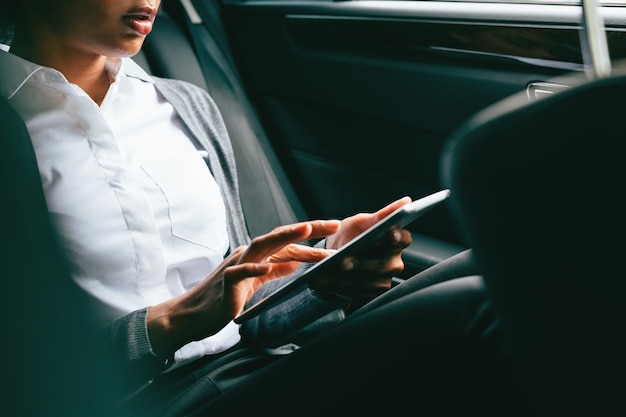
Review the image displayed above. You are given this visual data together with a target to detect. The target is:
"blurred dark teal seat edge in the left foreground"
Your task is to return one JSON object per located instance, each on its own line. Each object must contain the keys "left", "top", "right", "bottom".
{"left": 0, "top": 96, "right": 119, "bottom": 417}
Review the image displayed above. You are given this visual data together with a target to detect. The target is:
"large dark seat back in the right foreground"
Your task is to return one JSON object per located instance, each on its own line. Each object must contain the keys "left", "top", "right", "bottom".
{"left": 443, "top": 73, "right": 626, "bottom": 416}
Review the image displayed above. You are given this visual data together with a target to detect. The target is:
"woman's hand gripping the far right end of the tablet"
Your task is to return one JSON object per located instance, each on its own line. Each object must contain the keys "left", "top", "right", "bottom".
{"left": 311, "top": 197, "right": 411, "bottom": 305}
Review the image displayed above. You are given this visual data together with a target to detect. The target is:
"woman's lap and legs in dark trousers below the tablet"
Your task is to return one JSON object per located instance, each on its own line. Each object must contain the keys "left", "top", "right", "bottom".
{"left": 122, "top": 251, "right": 524, "bottom": 416}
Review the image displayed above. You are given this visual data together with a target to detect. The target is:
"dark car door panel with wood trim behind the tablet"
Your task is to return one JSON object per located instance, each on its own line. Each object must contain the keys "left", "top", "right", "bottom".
{"left": 199, "top": 0, "right": 623, "bottom": 272}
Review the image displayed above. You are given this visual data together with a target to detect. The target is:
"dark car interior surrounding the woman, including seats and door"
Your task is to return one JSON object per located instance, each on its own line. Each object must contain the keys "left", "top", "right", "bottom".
{"left": 0, "top": 0, "right": 626, "bottom": 416}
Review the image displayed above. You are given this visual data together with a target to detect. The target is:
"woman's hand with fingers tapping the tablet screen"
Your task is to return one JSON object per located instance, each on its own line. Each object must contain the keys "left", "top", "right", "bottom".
{"left": 147, "top": 220, "right": 340, "bottom": 357}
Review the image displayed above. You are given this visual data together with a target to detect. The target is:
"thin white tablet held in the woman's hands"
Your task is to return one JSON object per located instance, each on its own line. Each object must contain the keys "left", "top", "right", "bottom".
{"left": 235, "top": 189, "right": 450, "bottom": 323}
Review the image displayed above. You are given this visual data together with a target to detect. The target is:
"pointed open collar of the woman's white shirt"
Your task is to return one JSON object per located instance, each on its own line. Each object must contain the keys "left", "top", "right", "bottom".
{"left": 0, "top": 51, "right": 154, "bottom": 99}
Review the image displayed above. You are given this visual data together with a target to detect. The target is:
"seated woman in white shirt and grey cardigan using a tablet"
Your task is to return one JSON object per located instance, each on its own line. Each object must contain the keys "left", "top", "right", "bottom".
{"left": 0, "top": 0, "right": 528, "bottom": 415}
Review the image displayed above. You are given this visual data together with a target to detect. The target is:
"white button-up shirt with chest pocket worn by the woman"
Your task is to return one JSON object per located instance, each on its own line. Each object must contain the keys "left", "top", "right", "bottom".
{"left": 0, "top": 52, "right": 239, "bottom": 363}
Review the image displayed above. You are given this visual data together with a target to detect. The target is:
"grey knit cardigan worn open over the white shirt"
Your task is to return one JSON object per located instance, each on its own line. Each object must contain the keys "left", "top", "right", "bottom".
{"left": 106, "top": 77, "right": 345, "bottom": 383}
